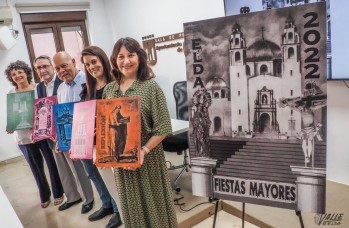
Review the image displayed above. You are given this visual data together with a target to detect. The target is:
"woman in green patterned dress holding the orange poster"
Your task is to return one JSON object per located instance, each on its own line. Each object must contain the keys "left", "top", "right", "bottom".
{"left": 103, "top": 37, "right": 178, "bottom": 228}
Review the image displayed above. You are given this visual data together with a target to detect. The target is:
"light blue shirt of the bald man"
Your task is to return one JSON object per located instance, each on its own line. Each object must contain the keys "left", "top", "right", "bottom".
{"left": 57, "top": 71, "right": 86, "bottom": 104}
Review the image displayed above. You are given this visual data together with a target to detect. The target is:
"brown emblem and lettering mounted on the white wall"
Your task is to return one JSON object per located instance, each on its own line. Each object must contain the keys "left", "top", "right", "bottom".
{"left": 142, "top": 32, "right": 184, "bottom": 66}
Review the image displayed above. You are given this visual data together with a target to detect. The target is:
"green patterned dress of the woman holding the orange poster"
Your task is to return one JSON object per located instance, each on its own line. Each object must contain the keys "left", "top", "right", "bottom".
{"left": 103, "top": 80, "right": 178, "bottom": 228}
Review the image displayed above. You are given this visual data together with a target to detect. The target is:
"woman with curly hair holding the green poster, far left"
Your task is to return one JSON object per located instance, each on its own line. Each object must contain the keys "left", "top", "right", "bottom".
{"left": 5, "top": 60, "right": 64, "bottom": 208}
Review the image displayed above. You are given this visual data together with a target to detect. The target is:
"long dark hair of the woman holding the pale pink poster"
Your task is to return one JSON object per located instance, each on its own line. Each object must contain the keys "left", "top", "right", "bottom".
{"left": 81, "top": 46, "right": 113, "bottom": 100}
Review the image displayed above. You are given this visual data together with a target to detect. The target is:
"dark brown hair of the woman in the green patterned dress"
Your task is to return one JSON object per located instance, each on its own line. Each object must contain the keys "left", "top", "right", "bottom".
{"left": 110, "top": 37, "right": 155, "bottom": 83}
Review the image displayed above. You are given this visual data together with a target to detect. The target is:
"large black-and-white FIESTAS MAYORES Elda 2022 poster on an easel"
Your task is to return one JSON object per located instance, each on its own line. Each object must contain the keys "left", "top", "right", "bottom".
{"left": 184, "top": 2, "right": 327, "bottom": 213}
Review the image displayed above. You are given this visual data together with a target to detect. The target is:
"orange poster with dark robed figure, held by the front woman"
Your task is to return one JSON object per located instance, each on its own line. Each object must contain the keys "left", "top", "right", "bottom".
{"left": 96, "top": 97, "right": 141, "bottom": 168}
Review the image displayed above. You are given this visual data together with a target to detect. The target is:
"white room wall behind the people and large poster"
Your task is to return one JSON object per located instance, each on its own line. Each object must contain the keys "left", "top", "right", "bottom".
{"left": 0, "top": 0, "right": 349, "bottom": 184}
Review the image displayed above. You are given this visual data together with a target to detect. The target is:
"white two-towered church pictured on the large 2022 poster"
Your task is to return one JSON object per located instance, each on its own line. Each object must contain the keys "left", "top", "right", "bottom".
{"left": 229, "top": 16, "right": 302, "bottom": 138}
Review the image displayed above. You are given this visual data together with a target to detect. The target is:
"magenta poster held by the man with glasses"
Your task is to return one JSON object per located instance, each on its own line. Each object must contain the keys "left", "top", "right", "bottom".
{"left": 32, "top": 96, "right": 57, "bottom": 142}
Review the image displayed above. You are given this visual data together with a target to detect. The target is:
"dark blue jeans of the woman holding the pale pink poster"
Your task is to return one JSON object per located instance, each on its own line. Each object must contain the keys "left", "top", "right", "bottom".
{"left": 81, "top": 159, "right": 119, "bottom": 213}
